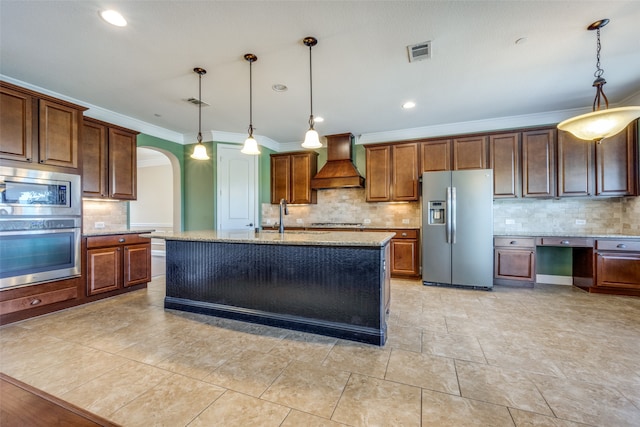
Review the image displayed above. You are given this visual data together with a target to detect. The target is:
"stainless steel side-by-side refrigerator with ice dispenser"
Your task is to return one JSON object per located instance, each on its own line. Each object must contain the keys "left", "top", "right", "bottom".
{"left": 422, "top": 169, "right": 493, "bottom": 289}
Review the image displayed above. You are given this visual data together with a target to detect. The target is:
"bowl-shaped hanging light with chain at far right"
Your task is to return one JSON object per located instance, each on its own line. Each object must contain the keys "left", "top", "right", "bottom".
{"left": 558, "top": 19, "right": 640, "bottom": 143}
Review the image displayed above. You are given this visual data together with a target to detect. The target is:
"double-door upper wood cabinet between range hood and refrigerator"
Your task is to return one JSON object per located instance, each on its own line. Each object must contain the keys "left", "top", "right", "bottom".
{"left": 365, "top": 142, "right": 420, "bottom": 202}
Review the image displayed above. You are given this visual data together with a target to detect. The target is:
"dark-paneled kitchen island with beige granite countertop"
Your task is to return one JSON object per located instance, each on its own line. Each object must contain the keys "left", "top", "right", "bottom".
{"left": 147, "top": 231, "right": 394, "bottom": 345}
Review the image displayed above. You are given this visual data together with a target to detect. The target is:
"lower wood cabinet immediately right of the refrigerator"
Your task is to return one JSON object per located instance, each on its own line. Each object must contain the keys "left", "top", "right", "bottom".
{"left": 493, "top": 237, "right": 536, "bottom": 286}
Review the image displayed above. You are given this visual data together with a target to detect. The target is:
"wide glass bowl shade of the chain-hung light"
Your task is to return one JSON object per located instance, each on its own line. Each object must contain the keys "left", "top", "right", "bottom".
{"left": 558, "top": 107, "right": 640, "bottom": 141}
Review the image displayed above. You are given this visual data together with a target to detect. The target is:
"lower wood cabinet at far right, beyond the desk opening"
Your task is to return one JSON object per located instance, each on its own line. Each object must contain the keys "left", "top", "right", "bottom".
{"left": 592, "top": 240, "right": 640, "bottom": 295}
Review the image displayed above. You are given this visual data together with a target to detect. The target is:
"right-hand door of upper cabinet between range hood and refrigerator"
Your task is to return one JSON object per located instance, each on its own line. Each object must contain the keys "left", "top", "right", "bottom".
{"left": 391, "top": 142, "right": 420, "bottom": 202}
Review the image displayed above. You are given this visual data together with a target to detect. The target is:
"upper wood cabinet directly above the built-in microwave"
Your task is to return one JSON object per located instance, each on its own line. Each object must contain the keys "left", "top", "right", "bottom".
{"left": 0, "top": 82, "right": 86, "bottom": 173}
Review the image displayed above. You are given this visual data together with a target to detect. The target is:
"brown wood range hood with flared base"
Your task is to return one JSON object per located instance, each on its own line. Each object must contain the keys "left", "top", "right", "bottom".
{"left": 311, "top": 133, "right": 364, "bottom": 190}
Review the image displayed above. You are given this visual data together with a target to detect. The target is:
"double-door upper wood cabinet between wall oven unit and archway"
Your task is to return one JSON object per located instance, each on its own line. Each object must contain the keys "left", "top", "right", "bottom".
{"left": 82, "top": 118, "right": 138, "bottom": 200}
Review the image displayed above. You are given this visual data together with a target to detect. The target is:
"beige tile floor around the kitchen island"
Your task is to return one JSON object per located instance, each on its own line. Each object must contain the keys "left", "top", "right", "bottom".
{"left": 0, "top": 266, "right": 640, "bottom": 427}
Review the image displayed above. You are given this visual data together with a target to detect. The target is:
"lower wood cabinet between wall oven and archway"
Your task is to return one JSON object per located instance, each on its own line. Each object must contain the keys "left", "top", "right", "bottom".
{"left": 86, "top": 234, "right": 151, "bottom": 296}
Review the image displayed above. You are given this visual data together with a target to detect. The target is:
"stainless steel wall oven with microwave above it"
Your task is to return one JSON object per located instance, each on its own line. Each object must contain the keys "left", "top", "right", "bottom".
{"left": 0, "top": 166, "right": 82, "bottom": 289}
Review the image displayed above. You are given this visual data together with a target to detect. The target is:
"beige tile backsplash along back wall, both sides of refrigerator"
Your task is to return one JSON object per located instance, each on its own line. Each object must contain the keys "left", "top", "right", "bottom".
{"left": 262, "top": 189, "right": 640, "bottom": 236}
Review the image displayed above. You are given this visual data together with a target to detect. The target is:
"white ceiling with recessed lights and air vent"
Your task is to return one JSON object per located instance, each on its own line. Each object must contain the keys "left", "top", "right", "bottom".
{"left": 0, "top": 0, "right": 640, "bottom": 149}
